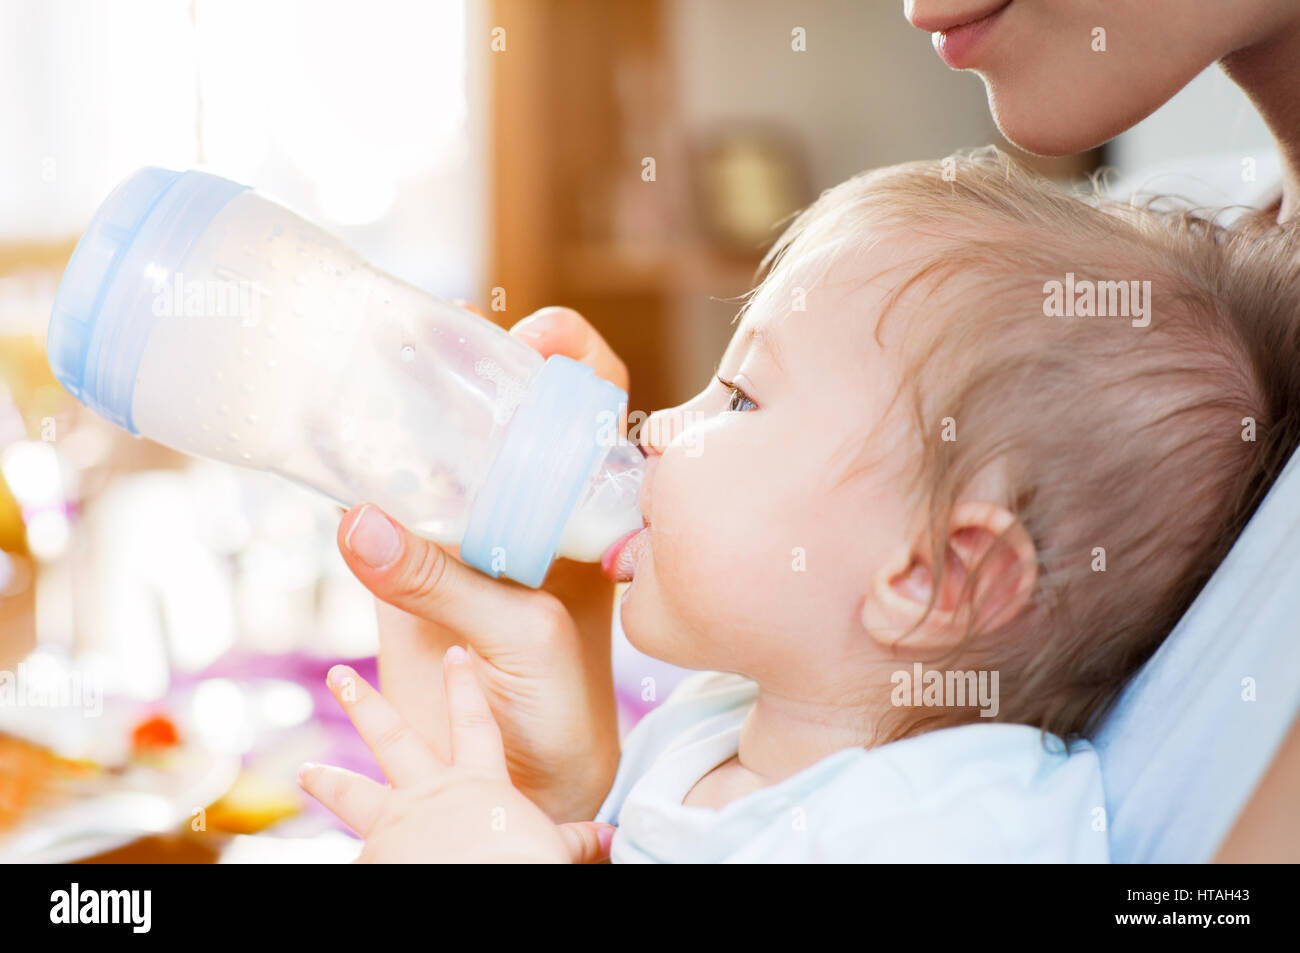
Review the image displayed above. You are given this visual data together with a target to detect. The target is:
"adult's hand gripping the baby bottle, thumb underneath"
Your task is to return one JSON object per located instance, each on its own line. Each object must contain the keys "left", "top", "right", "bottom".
{"left": 338, "top": 308, "right": 628, "bottom": 822}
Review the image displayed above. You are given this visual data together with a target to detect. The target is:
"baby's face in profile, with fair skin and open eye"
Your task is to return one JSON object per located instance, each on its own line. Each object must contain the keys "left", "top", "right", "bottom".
{"left": 621, "top": 246, "right": 917, "bottom": 689}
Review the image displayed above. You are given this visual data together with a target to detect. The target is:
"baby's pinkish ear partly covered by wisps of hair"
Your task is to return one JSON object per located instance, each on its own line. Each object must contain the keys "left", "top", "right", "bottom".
{"left": 862, "top": 503, "right": 1039, "bottom": 653}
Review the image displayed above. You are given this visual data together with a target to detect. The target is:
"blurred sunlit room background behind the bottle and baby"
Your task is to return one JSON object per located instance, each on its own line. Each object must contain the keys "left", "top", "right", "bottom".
{"left": 0, "top": 0, "right": 1269, "bottom": 861}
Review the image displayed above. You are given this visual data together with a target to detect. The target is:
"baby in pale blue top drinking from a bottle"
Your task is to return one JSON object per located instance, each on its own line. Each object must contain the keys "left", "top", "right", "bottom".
{"left": 297, "top": 151, "right": 1300, "bottom": 862}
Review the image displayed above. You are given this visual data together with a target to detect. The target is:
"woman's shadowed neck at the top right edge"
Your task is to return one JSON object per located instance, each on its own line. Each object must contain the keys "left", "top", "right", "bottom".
{"left": 1221, "top": 8, "right": 1300, "bottom": 222}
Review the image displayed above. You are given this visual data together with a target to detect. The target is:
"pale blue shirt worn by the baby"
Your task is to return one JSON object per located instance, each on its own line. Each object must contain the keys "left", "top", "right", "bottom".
{"left": 597, "top": 672, "right": 1108, "bottom": 863}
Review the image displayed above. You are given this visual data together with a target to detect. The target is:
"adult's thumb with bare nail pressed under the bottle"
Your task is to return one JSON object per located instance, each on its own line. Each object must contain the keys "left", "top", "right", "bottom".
{"left": 338, "top": 503, "right": 546, "bottom": 657}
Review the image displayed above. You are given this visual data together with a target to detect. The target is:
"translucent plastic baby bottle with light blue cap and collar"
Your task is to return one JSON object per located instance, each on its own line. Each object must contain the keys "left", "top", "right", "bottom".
{"left": 48, "top": 169, "right": 644, "bottom": 586}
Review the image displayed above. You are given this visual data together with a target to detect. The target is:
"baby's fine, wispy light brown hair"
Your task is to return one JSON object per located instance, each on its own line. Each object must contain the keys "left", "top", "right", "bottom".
{"left": 746, "top": 148, "right": 1300, "bottom": 741}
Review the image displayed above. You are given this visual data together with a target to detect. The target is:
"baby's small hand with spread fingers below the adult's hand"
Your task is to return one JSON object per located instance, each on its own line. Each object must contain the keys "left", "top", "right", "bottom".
{"left": 298, "top": 646, "right": 614, "bottom": 863}
